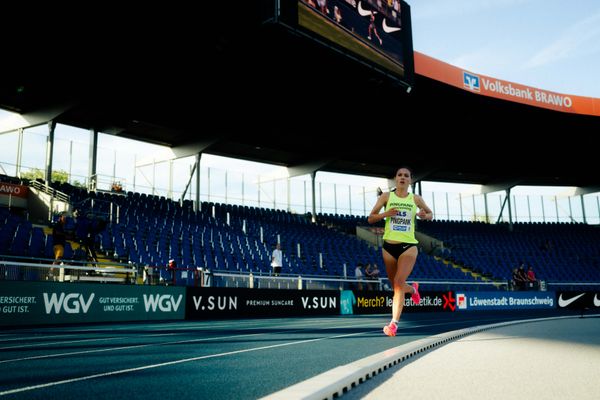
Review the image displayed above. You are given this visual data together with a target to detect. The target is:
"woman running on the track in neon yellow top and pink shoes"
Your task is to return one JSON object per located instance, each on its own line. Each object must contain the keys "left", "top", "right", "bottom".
{"left": 368, "top": 167, "right": 433, "bottom": 336}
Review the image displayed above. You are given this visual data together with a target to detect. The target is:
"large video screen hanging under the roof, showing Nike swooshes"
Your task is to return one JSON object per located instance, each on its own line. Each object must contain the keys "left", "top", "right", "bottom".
{"left": 280, "top": 0, "right": 414, "bottom": 86}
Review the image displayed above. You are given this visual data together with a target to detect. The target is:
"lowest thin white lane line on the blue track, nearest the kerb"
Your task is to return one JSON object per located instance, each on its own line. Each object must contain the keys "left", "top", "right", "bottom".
{"left": 0, "top": 325, "right": 374, "bottom": 396}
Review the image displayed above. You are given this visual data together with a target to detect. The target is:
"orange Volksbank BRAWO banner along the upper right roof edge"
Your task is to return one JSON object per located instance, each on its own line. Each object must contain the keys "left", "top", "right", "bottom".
{"left": 414, "top": 51, "right": 600, "bottom": 116}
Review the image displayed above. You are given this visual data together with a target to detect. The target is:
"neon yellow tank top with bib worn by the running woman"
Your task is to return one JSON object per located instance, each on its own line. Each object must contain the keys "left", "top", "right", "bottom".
{"left": 383, "top": 192, "right": 419, "bottom": 243}
